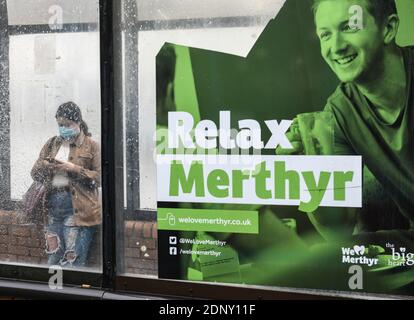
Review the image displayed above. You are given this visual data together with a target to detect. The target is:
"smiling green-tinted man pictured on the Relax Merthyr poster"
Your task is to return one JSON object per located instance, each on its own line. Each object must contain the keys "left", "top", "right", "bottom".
{"left": 279, "top": 0, "right": 414, "bottom": 241}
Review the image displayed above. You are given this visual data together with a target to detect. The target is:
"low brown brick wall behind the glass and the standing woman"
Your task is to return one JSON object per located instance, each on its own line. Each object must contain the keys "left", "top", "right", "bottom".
{"left": 0, "top": 210, "right": 158, "bottom": 275}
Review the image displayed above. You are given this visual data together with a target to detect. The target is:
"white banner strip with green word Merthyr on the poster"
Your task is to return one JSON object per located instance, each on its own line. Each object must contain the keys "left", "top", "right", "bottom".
{"left": 157, "top": 154, "right": 362, "bottom": 212}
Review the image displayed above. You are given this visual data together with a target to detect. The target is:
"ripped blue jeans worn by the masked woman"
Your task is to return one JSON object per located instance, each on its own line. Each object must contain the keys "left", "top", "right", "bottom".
{"left": 46, "top": 191, "right": 97, "bottom": 267}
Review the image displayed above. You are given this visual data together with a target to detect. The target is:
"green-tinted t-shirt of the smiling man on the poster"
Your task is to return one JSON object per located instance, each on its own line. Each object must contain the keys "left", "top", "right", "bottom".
{"left": 325, "top": 47, "right": 414, "bottom": 226}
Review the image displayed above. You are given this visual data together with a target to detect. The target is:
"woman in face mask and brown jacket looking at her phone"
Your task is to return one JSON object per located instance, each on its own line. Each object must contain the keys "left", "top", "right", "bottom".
{"left": 31, "top": 102, "right": 101, "bottom": 267}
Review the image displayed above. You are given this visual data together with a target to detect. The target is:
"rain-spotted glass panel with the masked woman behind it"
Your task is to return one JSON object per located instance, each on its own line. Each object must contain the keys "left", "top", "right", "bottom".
{"left": 0, "top": 0, "right": 101, "bottom": 270}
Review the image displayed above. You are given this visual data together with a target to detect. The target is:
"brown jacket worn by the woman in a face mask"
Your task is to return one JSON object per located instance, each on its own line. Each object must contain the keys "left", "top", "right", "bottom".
{"left": 31, "top": 132, "right": 101, "bottom": 226}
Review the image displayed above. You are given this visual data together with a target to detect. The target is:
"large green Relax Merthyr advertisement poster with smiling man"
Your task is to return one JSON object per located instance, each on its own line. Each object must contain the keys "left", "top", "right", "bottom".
{"left": 156, "top": 0, "right": 414, "bottom": 295}
